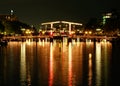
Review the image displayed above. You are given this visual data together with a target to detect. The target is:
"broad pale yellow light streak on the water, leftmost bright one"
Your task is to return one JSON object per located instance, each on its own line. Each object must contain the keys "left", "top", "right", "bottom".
{"left": 20, "top": 42, "right": 26, "bottom": 86}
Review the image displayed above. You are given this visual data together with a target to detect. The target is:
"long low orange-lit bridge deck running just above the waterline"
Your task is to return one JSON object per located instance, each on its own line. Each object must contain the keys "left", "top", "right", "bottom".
{"left": 2, "top": 35, "right": 117, "bottom": 41}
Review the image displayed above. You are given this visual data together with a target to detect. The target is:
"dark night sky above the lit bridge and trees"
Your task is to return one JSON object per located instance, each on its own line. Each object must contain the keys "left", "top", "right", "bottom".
{"left": 0, "top": 0, "right": 120, "bottom": 24}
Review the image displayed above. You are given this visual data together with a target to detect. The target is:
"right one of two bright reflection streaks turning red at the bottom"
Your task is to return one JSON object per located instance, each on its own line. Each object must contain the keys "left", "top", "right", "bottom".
{"left": 68, "top": 42, "right": 73, "bottom": 86}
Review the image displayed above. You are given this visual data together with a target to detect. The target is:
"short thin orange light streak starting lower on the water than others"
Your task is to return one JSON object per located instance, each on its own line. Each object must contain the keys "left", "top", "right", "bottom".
{"left": 88, "top": 53, "right": 92, "bottom": 86}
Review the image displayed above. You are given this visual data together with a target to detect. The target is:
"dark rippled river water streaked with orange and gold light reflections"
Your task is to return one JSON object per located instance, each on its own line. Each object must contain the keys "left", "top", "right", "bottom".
{"left": 0, "top": 39, "right": 120, "bottom": 86}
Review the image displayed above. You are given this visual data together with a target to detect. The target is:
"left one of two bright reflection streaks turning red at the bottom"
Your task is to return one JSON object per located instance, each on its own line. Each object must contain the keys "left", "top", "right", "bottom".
{"left": 49, "top": 42, "right": 53, "bottom": 86}
